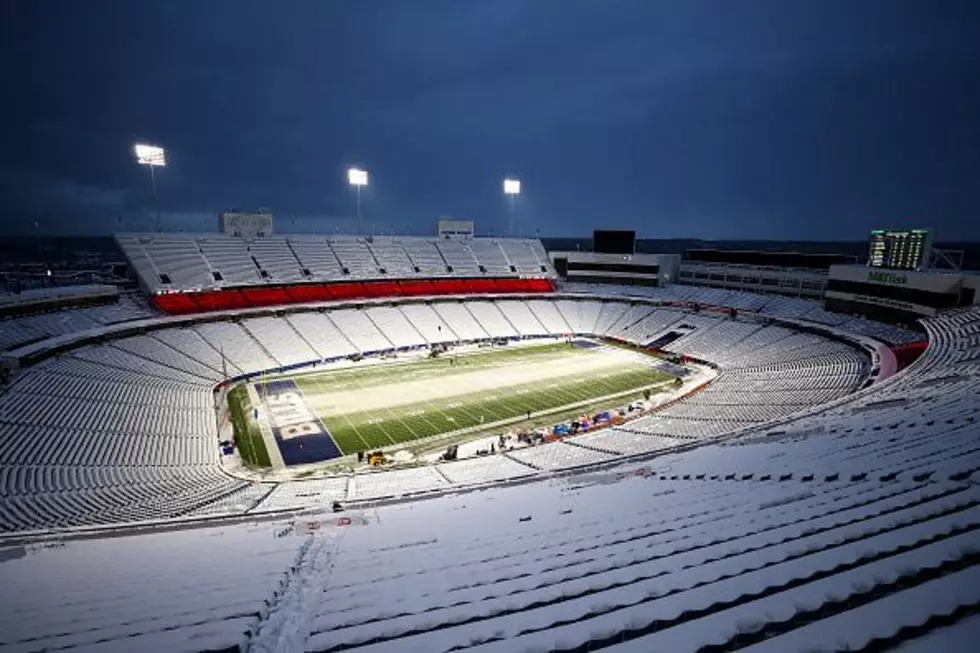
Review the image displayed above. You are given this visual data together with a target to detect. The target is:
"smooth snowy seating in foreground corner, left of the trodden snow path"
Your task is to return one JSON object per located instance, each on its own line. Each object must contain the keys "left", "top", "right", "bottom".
{"left": 0, "top": 524, "right": 302, "bottom": 653}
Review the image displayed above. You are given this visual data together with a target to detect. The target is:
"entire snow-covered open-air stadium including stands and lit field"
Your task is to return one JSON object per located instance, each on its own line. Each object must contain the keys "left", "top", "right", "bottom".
{"left": 0, "top": 214, "right": 980, "bottom": 652}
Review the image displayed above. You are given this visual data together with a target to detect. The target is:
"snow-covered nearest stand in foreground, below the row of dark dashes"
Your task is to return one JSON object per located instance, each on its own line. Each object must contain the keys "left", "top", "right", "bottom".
{"left": 0, "top": 470, "right": 980, "bottom": 653}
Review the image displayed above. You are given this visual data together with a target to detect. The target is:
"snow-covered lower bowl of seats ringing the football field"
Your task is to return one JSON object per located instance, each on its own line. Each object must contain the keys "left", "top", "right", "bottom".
{"left": 0, "top": 289, "right": 956, "bottom": 530}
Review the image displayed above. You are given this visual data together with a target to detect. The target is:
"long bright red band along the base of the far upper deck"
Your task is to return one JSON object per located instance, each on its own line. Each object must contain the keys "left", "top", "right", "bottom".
{"left": 153, "top": 279, "right": 555, "bottom": 315}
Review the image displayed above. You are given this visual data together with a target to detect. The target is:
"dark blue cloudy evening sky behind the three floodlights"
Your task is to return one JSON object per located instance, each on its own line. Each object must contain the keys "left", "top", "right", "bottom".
{"left": 0, "top": 0, "right": 980, "bottom": 240}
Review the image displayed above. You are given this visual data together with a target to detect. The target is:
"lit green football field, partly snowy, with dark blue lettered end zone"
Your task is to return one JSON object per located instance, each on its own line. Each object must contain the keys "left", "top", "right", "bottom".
{"left": 249, "top": 342, "right": 671, "bottom": 464}
